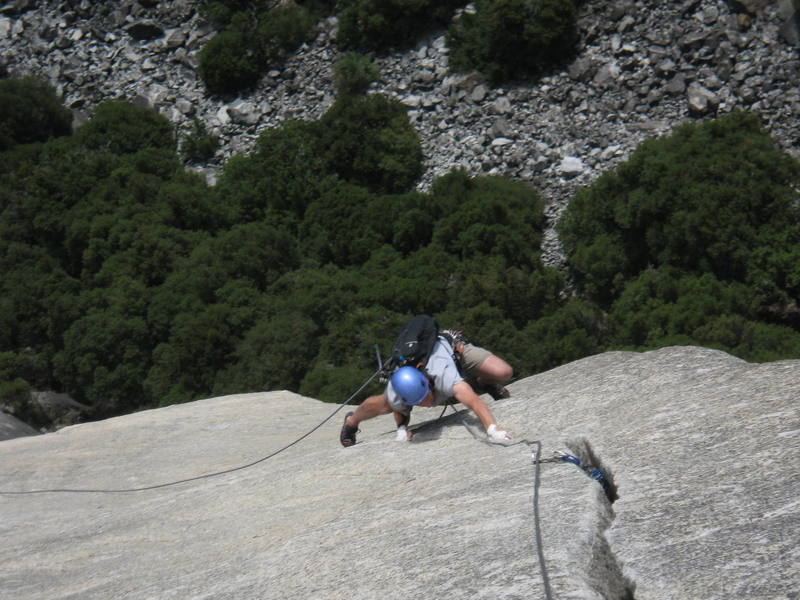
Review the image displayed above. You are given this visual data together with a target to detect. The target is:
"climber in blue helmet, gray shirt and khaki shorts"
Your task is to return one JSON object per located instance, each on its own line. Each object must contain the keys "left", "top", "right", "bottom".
{"left": 339, "top": 331, "right": 513, "bottom": 447}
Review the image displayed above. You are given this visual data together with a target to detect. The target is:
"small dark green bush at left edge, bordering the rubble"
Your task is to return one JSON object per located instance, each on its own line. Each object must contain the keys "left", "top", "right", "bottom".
{"left": 0, "top": 77, "right": 72, "bottom": 152}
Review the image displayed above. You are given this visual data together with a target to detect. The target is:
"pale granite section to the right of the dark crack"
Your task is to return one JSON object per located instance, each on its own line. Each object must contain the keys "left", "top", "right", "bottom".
{"left": 524, "top": 348, "right": 800, "bottom": 600}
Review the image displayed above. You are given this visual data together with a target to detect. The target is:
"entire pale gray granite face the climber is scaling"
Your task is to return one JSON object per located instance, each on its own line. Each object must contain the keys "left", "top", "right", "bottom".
{"left": 0, "top": 347, "right": 800, "bottom": 600}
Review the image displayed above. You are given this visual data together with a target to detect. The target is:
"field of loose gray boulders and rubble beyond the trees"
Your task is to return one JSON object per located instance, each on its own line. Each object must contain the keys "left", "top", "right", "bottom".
{"left": 0, "top": 0, "right": 800, "bottom": 265}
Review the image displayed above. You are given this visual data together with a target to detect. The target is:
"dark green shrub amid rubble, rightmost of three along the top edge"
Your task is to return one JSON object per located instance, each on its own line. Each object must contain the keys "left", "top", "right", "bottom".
{"left": 447, "top": 0, "right": 578, "bottom": 83}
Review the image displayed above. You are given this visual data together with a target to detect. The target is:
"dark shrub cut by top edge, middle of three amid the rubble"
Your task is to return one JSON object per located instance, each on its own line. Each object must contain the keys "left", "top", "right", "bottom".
{"left": 336, "top": 0, "right": 463, "bottom": 51}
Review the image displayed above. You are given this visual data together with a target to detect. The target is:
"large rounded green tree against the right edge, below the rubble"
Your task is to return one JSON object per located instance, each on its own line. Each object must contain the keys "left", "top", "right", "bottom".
{"left": 560, "top": 112, "right": 800, "bottom": 304}
